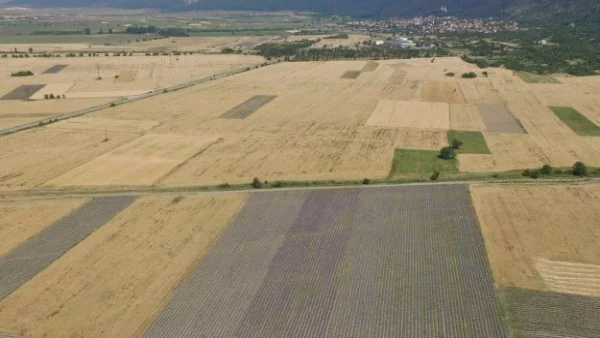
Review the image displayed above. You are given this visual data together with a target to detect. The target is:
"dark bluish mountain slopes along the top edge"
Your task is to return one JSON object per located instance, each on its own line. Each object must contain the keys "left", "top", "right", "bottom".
{"left": 10, "top": 0, "right": 600, "bottom": 20}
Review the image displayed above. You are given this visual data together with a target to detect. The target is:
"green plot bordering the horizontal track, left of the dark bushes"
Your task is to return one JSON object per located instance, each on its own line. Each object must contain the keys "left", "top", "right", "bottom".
{"left": 389, "top": 149, "right": 458, "bottom": 178}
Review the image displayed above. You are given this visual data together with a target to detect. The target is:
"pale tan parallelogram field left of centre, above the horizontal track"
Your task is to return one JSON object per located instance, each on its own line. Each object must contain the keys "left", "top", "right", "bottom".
{"left": 45, "top": 134, "right": 218, "bottom": 186}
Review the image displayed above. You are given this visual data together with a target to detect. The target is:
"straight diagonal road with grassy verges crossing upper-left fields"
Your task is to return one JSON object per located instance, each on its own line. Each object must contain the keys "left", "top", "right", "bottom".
{"left": 0, "top": 60, "right": 280, "bottom": 137}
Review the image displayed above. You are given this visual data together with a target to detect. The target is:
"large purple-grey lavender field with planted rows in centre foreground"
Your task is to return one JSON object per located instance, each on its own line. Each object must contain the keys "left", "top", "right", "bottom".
{"left": 143, "top": 185, "right": 507, "bottom": 338}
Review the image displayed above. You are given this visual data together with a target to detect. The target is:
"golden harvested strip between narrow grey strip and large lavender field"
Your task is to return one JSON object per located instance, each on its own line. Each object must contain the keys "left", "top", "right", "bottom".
{"left": 0, "top": 194, "right": 246, "bottom": 338}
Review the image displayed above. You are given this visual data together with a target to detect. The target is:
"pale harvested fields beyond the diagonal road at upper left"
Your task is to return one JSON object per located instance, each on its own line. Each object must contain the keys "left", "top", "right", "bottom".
{"left": 0, "top": 54, "right": 264, "bottom": 97}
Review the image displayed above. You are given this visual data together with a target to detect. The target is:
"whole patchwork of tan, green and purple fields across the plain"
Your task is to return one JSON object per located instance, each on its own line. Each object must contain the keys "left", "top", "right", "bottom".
{"left": 0, "top": 21, "right": 600, "bottom": 338}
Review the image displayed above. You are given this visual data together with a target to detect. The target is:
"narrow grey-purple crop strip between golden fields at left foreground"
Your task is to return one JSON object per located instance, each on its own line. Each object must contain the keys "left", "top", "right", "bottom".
{"left": 0, "top": 196, "right": 135, "bottom": 300}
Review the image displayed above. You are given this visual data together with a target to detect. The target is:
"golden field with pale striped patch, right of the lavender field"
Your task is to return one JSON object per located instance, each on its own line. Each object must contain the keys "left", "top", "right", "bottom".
{"left": 471, "top": 183, "right": 600, "bottom": 297}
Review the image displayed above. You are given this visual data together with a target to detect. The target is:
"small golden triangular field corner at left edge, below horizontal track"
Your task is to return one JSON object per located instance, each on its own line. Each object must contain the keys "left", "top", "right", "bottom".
{"left": 0, "top": 198, "right": 86, "bottom": 257}
